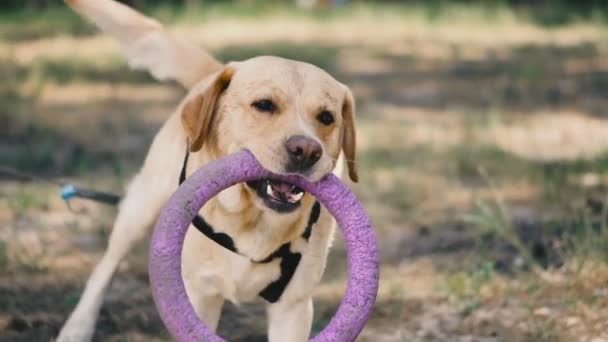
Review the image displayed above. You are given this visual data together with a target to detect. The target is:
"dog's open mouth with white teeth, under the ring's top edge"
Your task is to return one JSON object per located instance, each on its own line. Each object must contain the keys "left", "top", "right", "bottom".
{"left": 247, "top": 179, "right": 305, "bottom": 213}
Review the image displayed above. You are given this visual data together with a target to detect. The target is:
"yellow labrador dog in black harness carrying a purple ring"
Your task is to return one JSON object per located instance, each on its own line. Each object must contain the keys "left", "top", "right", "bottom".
{"left": 58, "top": 0, "right": 357, "bottom": 342}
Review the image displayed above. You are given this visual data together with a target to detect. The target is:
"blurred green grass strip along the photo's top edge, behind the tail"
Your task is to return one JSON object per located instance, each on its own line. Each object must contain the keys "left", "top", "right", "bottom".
{"left": 0, "top": 0, "right": 608, "bottom": 42}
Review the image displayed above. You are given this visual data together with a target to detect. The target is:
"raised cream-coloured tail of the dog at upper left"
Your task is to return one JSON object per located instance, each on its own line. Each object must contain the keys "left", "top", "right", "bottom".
{"left": 65, "top": 0, "right": 222, "bottom": 89}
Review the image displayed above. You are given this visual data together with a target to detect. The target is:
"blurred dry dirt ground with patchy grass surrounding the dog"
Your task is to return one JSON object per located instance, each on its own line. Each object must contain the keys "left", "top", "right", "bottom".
{"left": 0, "top": 3, "right": 608, "bottom": 342}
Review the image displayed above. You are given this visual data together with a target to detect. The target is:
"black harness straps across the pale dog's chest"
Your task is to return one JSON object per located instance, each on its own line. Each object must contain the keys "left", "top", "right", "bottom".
{"left": 179, "top": 144, "right": 321, "bottom": 303}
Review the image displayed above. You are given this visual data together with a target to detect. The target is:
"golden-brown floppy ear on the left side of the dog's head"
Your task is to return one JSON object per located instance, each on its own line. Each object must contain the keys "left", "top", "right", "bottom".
{"left": 181, "top": 67, "right": 234, "bottom": 152}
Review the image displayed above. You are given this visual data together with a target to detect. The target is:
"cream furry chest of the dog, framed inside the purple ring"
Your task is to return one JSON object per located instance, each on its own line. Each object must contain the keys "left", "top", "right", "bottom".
{"left": 182, "top": 198, "right": 332, "bottom": 303}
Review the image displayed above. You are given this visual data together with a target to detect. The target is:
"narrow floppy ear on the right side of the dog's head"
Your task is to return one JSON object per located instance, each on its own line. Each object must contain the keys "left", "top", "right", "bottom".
{"left": 342, "top": 87, "right": 359, "bottom": 182}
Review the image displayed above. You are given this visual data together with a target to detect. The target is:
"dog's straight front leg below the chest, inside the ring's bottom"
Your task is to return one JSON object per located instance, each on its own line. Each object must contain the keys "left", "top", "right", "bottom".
{"left": 268, "top": 297, "right": 313, "bottom": 342}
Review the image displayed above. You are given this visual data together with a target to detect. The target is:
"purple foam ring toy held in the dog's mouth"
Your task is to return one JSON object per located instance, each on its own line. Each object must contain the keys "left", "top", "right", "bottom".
{"left": 149, "top": 150, "right": 379, "bottom": 342}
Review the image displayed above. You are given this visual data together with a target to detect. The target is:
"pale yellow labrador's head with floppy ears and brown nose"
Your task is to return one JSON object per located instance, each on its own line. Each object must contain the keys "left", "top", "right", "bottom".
{"left": 181, "top": 56, "right": 358, "bottom": 212}
